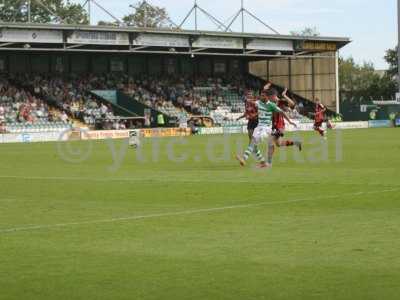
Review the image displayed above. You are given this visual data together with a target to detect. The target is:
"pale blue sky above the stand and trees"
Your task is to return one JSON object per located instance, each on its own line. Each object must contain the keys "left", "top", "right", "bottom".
{"left": 73, "top": 0, "right": 397, "bottom": 69}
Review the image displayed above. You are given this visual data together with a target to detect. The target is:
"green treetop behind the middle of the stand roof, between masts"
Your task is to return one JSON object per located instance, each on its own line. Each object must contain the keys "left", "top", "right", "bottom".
{"left": 122, "top": 1, "right": 171, "bottom": 28}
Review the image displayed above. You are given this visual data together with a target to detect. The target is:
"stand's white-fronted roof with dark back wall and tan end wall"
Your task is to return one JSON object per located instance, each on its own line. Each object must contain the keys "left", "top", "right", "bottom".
{"left": 0, "top": 23, "right": 350, "bottom": 111}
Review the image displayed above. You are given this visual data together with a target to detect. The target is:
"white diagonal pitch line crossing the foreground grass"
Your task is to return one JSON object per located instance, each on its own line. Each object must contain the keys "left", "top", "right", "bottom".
{"left": 0, "top": 188, "right": 400, "bottom": 234}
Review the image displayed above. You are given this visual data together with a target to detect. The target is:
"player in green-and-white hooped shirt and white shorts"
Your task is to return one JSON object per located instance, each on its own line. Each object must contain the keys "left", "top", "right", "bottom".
{"left": 237, "top": 89, "right": 296, "bottom": 168}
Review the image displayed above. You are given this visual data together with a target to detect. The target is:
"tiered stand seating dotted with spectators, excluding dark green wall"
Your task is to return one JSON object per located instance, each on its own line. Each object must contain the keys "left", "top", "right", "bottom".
{"left": 0, "top": 74, "right": 316, "bottom": 132}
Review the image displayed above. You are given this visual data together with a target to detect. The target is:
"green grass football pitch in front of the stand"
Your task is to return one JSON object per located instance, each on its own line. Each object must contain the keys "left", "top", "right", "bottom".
{"left": 0, "top": 129, "right": 400, "bottom": 300}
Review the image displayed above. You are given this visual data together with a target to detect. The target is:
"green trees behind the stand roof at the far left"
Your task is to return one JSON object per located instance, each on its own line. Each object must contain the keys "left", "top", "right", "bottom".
{"left": 0, "top": 0, "right": 89, "bottom": 24}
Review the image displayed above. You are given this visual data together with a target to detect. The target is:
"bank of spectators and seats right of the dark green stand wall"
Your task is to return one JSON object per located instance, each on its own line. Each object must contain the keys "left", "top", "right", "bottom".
{"left": 113, "top": 76, "right": 268, "bottom": 126}
